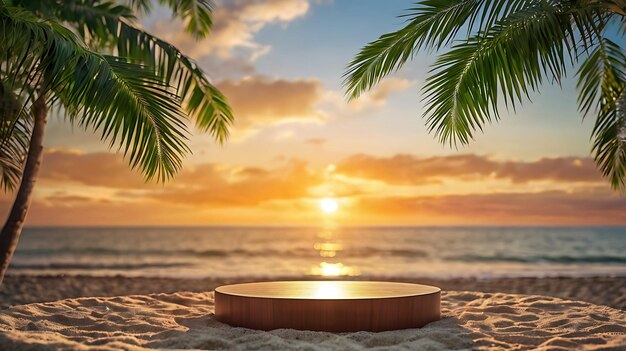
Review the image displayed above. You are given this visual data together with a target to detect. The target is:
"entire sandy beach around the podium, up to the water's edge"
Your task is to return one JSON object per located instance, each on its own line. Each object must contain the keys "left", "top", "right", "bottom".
{"left": 0, "top": 275, "right": 626, "bottom": 350}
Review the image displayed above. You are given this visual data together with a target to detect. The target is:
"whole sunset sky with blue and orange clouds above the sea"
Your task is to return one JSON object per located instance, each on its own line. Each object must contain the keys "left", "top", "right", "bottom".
{"left": 0, "top": 0, "right": 626, "bottom": 225}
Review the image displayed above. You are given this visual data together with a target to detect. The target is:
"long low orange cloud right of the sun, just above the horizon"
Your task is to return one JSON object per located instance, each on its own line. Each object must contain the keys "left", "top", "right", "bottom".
{"left": 353, "top": 188, "right": 626, "bottom": 225}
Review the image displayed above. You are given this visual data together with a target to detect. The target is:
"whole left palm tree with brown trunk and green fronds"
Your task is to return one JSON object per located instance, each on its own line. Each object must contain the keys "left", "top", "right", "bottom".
{"left": 0, "top": 0, "right": 233, "bottom": 283}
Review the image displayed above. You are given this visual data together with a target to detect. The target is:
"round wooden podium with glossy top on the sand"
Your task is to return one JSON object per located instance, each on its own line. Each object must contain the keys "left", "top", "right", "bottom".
{"left": 215, "top": 281, "right": 441, "bottom": 332}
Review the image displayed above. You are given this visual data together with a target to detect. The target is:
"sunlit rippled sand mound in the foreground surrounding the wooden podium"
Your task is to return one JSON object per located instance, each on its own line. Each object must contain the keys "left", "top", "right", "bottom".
{"left": 0, "top": 292, "right": 626, "bottom": 351}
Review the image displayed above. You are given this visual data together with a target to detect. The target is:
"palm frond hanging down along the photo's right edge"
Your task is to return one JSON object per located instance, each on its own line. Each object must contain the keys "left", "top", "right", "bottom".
{"left": 577, "top": 38, "right": 626, "bottom": 190}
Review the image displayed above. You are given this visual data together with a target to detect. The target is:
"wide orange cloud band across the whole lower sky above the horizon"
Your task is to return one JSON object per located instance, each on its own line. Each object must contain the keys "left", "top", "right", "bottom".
{"left": 0, "top": 150, "right": 626, "bottom": 225}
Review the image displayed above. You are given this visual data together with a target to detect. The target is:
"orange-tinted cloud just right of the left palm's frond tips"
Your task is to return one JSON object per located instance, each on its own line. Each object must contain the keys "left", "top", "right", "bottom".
{"left": 217, "top": 76, "right": 325, "bottom": 130}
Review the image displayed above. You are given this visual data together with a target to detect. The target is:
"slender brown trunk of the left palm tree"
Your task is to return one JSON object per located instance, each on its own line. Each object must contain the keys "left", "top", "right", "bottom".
{"left": 0, "top": 95, "right": 48, "bottom": 284}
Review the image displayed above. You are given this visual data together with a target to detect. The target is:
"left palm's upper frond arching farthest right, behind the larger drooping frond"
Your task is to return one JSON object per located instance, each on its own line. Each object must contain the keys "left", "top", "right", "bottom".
{"left": 44, "top": 0, "right": 234, "bottom": 143}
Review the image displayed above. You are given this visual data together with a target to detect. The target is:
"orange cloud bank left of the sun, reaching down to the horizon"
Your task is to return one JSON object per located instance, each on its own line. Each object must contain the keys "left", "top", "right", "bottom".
{"left": 0, "top": 150, "right": 323, "bottom": 225}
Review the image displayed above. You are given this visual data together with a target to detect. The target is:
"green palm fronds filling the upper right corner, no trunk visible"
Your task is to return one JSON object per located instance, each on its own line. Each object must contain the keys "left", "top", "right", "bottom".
{"left": 344, "top": 0, "right": 626, "bottom": 190}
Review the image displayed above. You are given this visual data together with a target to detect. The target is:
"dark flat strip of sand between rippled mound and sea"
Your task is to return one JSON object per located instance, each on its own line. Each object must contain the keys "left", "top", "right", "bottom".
{"left": 0, "top": 274, "right": 626, "bottom": 311}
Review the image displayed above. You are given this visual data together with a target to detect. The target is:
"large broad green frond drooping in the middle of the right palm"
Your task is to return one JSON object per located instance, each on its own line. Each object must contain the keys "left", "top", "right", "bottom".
{"left": 423, "top": 2, "right": 571, "bottom": 144}
